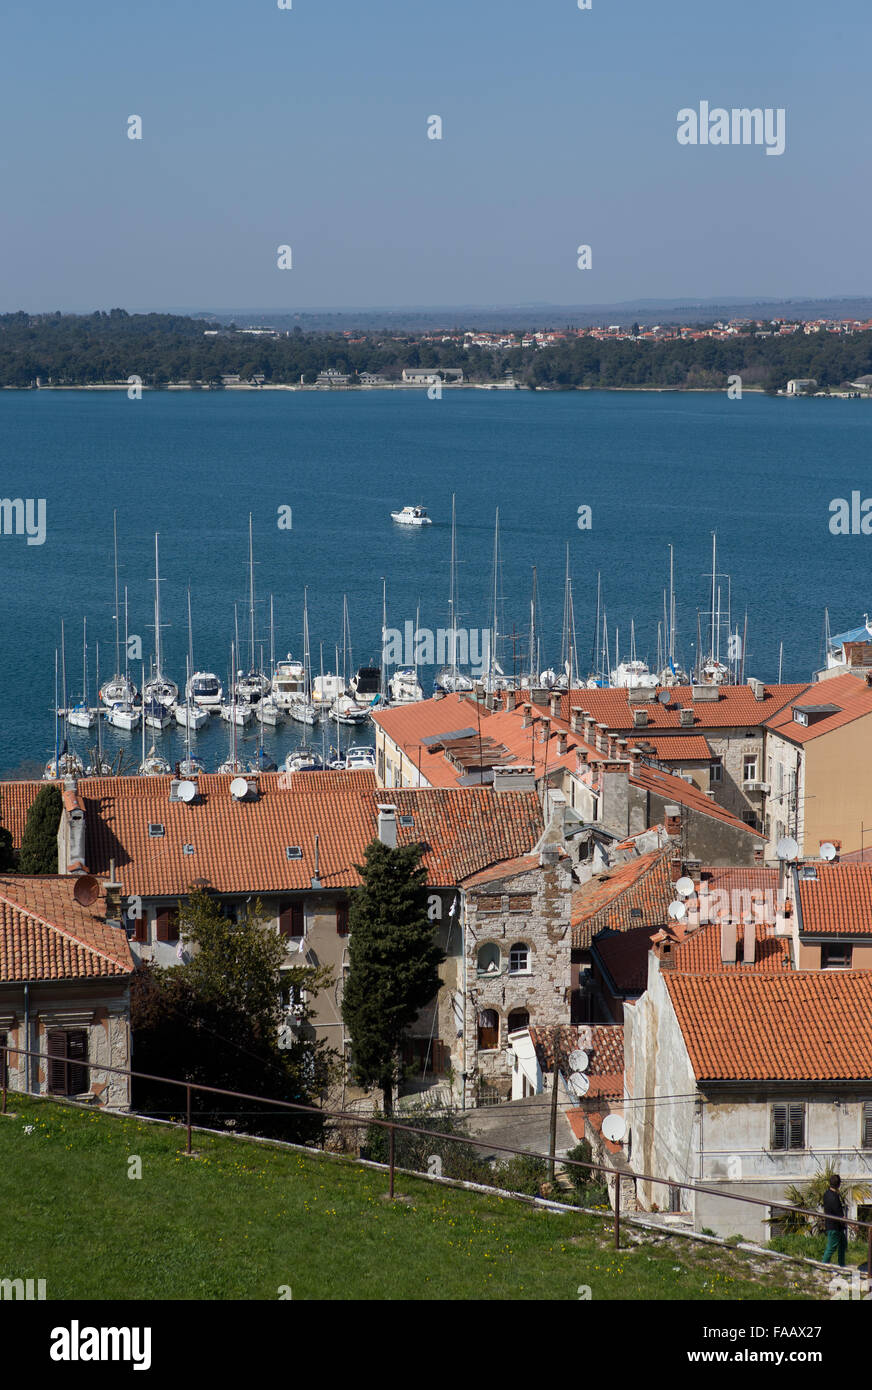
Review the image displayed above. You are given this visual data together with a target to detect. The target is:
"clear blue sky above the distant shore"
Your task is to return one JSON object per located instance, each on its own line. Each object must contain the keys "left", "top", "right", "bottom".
{"left": 0, "top": 0, "right": 872, "bottom": 310}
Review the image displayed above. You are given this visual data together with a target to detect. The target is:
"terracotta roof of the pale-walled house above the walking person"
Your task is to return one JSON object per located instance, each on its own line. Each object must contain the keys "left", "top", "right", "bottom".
{"left": 663, "top": 970, "right": 872, "bottom": 1083}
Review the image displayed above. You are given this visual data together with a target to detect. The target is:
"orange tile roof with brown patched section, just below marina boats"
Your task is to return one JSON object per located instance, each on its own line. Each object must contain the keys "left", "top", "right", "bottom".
{"left": 373, "top": 695, "right": 592, "bottom": 787}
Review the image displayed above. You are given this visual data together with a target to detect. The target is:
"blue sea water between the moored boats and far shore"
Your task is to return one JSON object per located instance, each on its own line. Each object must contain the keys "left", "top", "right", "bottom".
{"left": 0, "top": 391, "right": 872, "bottom": 776}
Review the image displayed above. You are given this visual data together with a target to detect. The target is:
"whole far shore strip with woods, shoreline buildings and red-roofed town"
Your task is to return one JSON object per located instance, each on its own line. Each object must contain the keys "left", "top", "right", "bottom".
{"left": 0, "top": 309, "right": 872, "bottom": 396}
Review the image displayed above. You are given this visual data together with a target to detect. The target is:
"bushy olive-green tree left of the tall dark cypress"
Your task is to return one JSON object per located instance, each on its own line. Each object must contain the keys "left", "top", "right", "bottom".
{"left": 131, "top": 890, "right": 334, "bottom": 1138}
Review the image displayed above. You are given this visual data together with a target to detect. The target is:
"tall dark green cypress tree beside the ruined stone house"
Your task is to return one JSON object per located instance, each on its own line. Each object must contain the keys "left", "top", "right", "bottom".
{"left": 342, "top": 840, "right": 445, "bottom": 1115}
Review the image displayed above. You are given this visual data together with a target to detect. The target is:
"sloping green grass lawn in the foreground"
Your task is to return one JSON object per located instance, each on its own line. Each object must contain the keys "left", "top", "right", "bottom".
{"left": 0, "top": 1095, "right": 826, "bottom": 1300}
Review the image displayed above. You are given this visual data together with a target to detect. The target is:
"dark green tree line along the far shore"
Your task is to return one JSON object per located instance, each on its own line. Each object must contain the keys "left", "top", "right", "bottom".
{"left": 0, "top": 309, "right": 872, "bottom": 391}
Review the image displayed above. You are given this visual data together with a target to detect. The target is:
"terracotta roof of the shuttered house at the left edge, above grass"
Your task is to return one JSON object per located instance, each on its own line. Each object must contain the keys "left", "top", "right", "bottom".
{"left": 0, "top": 874, "right": 134, "bottom": 981}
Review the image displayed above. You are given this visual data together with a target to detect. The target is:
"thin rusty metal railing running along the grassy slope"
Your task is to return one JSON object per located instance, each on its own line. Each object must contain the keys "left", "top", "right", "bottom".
{"left": 0, "top": 1043, "right": 872, "bottom": 1279}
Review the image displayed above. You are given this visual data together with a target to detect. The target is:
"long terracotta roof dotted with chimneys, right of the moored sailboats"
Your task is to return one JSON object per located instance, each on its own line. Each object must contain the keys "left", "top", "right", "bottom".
{"left": 560, "top": 682, "right": 806, "bottom": 735}
